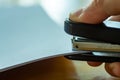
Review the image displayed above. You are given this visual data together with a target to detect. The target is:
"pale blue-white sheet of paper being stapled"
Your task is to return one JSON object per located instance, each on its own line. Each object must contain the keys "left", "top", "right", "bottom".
{"left": 0, "top": 7, "right": 75, "bottom": 72}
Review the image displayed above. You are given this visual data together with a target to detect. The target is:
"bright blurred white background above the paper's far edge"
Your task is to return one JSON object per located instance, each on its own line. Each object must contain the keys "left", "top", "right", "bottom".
{"left": 0, "top": 0, "right": 91, "bottom": 25}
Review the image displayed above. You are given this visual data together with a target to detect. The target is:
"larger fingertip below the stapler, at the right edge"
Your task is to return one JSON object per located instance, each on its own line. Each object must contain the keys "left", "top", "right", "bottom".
{"left": 105, "top": 62, "right": 120, "bottom": 77}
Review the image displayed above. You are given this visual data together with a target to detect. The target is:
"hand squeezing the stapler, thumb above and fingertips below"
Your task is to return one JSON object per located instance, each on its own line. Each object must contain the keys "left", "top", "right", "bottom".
{"left": 70, "top": 0, "right": 120, "bottom": 77}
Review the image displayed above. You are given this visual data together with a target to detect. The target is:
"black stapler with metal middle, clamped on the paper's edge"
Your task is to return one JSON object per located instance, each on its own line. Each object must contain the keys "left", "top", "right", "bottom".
{"left": 64, "top": 19, "right": 120, "bottom": 62}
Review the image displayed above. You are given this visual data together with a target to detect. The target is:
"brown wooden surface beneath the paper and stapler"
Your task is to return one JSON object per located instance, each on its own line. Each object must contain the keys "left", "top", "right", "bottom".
{"left": 0, "top": 57, "right": 120, "bottom": 80}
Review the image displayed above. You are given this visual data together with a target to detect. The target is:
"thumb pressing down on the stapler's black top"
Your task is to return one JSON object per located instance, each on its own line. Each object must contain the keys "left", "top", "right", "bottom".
{"left": 70, "top": 1, "right": 110, "bottom": 24}
